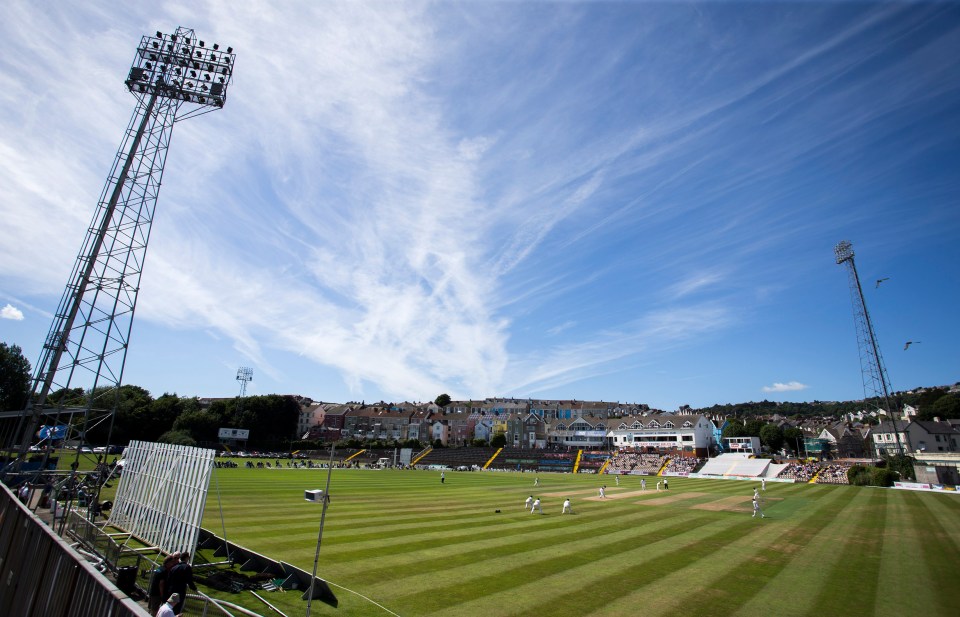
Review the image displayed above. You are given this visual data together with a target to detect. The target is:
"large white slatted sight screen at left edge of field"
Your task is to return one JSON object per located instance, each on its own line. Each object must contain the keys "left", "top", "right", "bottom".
{"left": 108, "top": 441, "right": 216, "bottom": 556}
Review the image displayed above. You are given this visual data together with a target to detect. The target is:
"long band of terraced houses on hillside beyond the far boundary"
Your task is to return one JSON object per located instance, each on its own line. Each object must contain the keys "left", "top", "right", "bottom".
{"left": 298, "top": 398, "right": 960, "bottom": 458}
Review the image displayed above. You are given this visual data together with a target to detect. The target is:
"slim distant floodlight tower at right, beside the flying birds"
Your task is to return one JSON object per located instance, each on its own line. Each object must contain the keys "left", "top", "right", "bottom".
{"left": 833, "top": 240, "right": 903, "bottom": 454}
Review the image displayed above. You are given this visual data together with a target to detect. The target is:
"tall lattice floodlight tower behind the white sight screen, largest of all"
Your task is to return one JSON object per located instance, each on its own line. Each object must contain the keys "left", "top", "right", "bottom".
{"left": 8, "top": 27, "right": 236, "bottom": 468}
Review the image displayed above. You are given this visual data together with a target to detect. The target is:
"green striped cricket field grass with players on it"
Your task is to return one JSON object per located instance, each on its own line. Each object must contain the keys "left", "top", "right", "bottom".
{"left": 189, "top": 469, "right": 960, "bottom": 617}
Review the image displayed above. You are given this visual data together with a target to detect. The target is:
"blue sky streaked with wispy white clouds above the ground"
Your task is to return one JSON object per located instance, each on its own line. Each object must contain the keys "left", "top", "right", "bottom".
{"left": 0, "top": 0, "right": 960, "bottom": 409}
